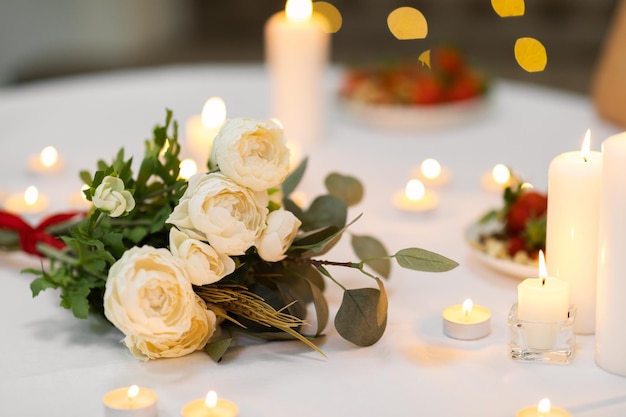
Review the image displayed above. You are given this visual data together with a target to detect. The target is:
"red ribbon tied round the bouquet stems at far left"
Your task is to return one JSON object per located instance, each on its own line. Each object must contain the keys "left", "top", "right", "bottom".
{"left": 0, "top": 211, "right": 84, "bottom": 256}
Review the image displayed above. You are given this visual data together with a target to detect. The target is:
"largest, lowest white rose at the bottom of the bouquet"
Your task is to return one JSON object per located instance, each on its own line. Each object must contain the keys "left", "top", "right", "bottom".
{"left": 104, "top": 246, "right": 215, "bottom": 359}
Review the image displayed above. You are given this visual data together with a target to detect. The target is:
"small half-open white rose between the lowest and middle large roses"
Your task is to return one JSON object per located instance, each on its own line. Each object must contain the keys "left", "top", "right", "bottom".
{"left": 170, "top": 227, "right": 235, "bottom": 285}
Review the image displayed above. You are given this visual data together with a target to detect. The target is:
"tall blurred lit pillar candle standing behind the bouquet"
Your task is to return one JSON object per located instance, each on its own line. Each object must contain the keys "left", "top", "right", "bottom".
{"left": 265, "top": 0, "right": 330, "bottom": 147}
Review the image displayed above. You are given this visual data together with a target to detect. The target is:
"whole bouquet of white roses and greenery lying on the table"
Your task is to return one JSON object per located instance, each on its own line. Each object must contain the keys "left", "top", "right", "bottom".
{"left": 13, "top": 111, "right": 457, "bottom": 360}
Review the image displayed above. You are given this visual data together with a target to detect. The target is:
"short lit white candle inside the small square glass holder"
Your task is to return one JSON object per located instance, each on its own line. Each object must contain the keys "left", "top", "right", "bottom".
{"left": 517, "top": 251, "right": 569, "bottom": 350}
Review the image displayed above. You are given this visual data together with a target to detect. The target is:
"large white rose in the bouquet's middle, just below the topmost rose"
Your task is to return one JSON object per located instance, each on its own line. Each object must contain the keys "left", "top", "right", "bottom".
{"left": 167, "top": 172, "right": 269, "bottom": 255}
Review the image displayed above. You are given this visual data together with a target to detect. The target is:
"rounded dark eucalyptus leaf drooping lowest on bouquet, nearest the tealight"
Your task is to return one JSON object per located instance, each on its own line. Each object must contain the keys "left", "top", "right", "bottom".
{"left": 335, "top": 288, "right": 387, "bottom": 346}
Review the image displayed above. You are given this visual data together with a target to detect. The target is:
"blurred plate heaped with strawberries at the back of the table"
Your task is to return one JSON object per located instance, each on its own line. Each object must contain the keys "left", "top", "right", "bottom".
{"left": 339, "top": 45, "right": 489, "bottom": 128}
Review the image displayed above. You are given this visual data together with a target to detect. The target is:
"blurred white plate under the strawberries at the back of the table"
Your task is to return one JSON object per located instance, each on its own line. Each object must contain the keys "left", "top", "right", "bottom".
{"left": 340, "top": 96, "right": 489, "bottom": 130}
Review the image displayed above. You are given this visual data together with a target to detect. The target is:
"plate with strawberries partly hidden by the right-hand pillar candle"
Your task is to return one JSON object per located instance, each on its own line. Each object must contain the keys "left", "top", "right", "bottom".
{"left": 465, "top": 178, "right": 548, "bottom": 278}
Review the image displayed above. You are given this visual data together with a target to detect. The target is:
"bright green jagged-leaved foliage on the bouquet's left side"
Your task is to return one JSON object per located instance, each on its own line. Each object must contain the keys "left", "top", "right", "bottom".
{"left": 26, "top": 110, "right": 186, "bottom": 318}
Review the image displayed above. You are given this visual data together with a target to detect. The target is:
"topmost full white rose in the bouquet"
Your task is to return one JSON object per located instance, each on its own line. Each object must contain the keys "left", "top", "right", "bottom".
{"left": 210, "top": 118, "right": 289, "bottom": 191}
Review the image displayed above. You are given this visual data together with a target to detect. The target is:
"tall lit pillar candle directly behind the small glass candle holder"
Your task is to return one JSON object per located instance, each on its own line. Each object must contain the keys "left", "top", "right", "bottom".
{"left": 546, "top": 131, "right": 602, "bottom": 334}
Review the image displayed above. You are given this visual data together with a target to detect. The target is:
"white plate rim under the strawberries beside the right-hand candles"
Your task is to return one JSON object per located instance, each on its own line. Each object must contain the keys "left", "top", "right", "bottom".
{"left": 465, "top": 221, "right": 538, "bottom": 278}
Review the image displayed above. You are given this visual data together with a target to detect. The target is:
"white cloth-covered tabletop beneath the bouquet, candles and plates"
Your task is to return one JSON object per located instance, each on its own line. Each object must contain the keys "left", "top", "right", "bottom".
{"left": 0, "top": 65, "right": 626, "bottom": 417}
